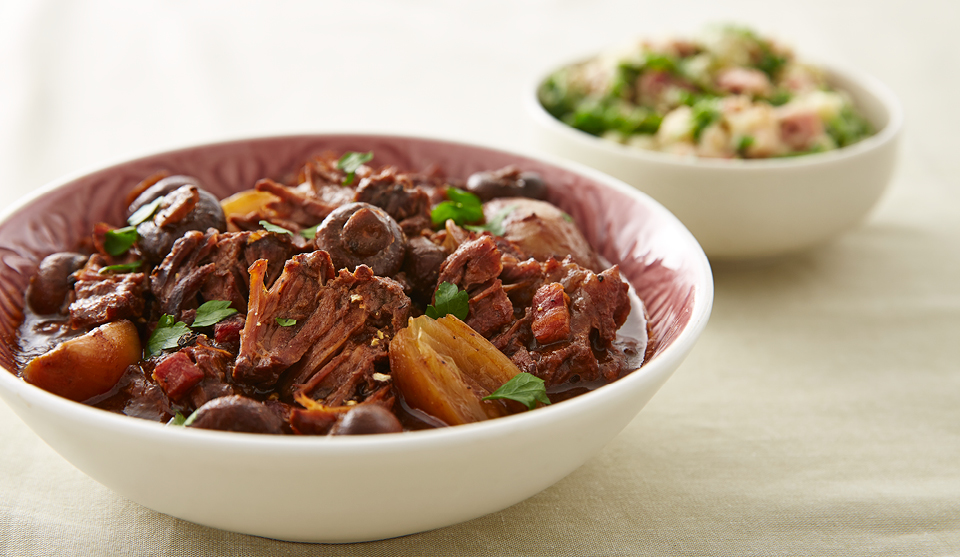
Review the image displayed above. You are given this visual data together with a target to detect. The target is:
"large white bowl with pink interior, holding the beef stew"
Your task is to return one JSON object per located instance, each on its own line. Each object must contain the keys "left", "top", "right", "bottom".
{"left": 0, "top": 135, "right": 713, "bottom": 542}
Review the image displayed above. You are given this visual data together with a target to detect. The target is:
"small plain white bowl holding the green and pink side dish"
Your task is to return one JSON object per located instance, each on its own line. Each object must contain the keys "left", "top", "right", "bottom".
{"left": 526, "top": 63, "right": 903, "bottom": 259}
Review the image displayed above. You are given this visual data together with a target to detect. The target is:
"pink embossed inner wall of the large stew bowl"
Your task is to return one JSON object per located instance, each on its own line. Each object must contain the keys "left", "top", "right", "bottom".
{"left": 0, "top": 135, "right": 709, "bottom": 396}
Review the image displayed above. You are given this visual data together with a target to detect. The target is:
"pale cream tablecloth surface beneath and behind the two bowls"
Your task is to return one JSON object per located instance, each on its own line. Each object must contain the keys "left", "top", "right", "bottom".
{"left": 0, "top": 0, "right": 960, "bottom": 556}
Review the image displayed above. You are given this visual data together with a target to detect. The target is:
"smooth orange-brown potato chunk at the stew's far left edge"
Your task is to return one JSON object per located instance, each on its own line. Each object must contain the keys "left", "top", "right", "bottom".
{"left": 23, "top": 320, "right": 142, "bottom": 402}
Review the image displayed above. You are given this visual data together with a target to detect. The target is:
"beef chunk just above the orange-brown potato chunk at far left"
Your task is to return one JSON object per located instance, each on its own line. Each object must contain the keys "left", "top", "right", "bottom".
{"left": 68, "top": 255, "right": 147, "bottom": 329}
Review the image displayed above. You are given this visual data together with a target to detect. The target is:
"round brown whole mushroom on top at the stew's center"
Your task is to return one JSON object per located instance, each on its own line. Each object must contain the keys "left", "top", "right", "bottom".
{"left": 316, "top": 203, "right": 406, "bottom": 276}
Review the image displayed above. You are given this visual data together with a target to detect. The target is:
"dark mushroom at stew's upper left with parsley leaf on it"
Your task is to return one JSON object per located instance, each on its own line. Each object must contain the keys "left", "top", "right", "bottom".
{"left": 127, "top": 176, "right": 227, "bottom": 262}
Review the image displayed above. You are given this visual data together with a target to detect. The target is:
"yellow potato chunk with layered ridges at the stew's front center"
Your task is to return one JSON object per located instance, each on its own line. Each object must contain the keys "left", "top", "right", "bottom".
{"left": 390, "top": 315, "right": 520, "bottom": 425}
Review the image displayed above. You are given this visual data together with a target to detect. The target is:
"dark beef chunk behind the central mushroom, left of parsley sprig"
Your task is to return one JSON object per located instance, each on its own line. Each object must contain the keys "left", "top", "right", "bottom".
{"left": 354, "top": 167, "right": 431, "bottom": 236}
